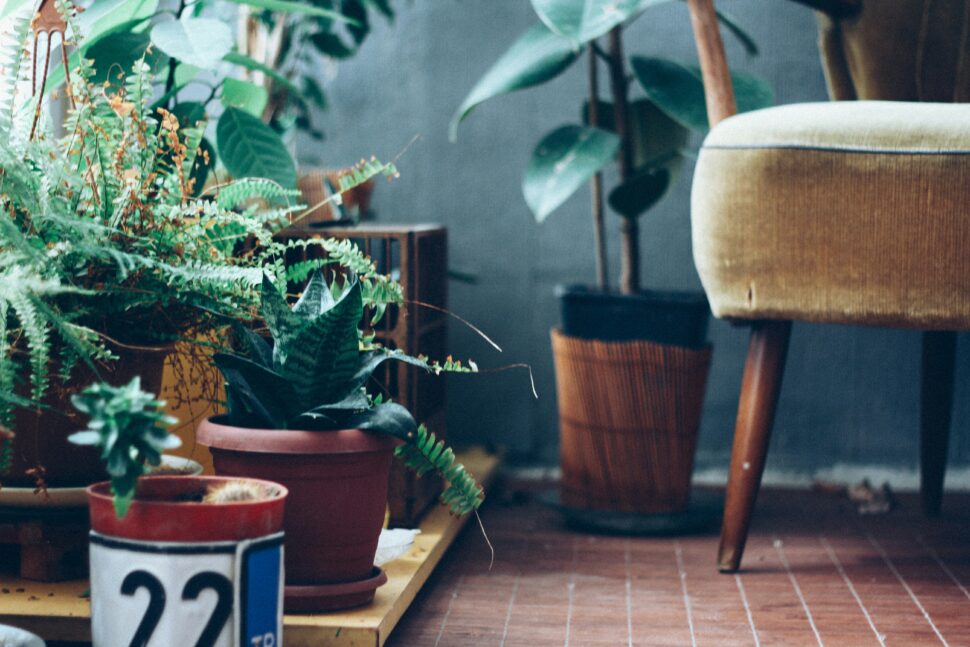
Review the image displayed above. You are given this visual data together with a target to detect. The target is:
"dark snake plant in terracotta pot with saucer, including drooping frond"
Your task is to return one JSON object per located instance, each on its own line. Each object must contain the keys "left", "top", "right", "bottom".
{"left": 198, "top": 272, "right": 483, "bottom": 611}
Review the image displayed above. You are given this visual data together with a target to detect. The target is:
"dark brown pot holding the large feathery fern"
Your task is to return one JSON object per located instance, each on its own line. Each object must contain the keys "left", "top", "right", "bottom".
{"left": 6, "top": 347, "right": 172, "bottom": 487}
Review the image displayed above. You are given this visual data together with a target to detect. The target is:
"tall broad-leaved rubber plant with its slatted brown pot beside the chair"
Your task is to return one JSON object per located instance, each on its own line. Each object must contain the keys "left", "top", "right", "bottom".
{"left": 451, "top": 0, "right": 771, "bottom": 514}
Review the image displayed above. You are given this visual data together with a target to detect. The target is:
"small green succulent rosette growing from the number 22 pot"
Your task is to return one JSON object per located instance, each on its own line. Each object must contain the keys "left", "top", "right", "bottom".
{"left": 68, "top": 377, "right": 182, "bottom": 517}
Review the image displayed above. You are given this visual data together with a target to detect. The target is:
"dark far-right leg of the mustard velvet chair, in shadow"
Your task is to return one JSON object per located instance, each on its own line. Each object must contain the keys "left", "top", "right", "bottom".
{"left": 920, "top": 331, "right": 957, "bottom": 517}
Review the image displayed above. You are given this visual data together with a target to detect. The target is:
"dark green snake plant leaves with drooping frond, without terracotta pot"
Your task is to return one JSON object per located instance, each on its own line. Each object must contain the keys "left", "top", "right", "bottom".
{"left": 214, "top": 271, "right": 483, "bottom": 514}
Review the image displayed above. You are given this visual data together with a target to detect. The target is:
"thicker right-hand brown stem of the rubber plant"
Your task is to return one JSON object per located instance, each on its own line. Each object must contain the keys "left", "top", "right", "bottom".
{"left": 609, "top": 26, "right": 640, "bottom": 294}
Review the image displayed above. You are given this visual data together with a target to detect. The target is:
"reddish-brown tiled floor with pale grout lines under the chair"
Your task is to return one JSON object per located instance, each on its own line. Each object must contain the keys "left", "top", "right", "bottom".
{"left": 387, "top": 490, "right": 970, "bottom": 647}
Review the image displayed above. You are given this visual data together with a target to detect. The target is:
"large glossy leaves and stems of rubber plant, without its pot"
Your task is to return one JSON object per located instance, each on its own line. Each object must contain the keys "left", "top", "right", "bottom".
{"left": 451, "top": 0, "right": 772, "bottom": 294}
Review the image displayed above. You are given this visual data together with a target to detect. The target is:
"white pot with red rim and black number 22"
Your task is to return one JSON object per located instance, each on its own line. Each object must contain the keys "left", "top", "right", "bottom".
{"left": 87, "top": 476, "right": 287, "bottom": 647}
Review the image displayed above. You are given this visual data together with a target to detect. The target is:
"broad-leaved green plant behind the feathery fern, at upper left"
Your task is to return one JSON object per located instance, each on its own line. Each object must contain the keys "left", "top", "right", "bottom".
{"left": 0, "top": 0, "right": 393, "bottom": 192}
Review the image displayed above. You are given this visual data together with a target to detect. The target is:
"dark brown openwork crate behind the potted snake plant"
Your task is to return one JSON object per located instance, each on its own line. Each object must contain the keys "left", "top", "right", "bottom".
{"left": 282, "top": 224, "right": 448, "bottom": 527}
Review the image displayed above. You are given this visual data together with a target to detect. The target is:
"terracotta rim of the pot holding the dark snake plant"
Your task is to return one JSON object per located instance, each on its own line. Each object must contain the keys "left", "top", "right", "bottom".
{"left": 196, "top": 416, "right": 401, "bottom": 454}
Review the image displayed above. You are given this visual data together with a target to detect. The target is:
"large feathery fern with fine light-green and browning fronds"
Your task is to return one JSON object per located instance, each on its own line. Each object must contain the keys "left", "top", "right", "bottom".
{"left": 0, "top": 10, "right": 400, "bottom": 480}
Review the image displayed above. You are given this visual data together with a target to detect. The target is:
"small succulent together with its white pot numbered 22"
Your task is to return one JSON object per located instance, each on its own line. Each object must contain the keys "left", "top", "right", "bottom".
{"left": 70, "top": 377, "right": 286, "bottom": 647}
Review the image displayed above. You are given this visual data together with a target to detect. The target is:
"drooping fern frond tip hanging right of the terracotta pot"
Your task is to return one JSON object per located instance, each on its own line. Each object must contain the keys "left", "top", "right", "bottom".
{"left": 394, "top": 425, "right": 485, "bottom": 515}
